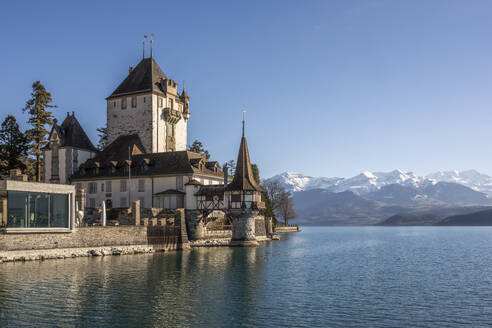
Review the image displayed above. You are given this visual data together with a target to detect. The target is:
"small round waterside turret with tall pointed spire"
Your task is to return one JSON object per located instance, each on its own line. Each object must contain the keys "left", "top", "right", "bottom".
{"left": 225, "top": 121, "right": 265, "bottom": 246}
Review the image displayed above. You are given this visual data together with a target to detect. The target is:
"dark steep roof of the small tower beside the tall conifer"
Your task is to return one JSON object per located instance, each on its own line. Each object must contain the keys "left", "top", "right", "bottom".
{"left": 48, "top": 113, "right": 96, "bottom": 151}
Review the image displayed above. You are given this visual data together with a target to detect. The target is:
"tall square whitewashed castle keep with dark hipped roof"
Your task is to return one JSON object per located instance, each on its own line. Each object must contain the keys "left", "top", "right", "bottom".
{"left": 106, "top": 58, "right": 190, "bottom": 153}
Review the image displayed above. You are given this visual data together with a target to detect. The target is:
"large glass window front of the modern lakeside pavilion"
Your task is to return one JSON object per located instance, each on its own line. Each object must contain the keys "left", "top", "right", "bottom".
{"left": 6, "top": 191, "right": 70, "bottom": 228}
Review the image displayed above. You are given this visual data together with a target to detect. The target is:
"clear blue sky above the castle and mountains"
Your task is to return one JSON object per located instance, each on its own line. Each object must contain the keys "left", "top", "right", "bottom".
{"left": 0, "top": 0, "right": 492, "bottom": 177}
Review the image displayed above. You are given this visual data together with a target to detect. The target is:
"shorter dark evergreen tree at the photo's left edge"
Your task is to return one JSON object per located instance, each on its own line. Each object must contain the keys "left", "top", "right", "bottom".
{"left": 0, "top": 115, "right": 28, "bottom": 175}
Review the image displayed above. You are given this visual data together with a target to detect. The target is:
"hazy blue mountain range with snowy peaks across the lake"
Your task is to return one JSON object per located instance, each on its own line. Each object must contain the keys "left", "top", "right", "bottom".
{"left": 268, "top": 170, "right": 492, "bottom": 225}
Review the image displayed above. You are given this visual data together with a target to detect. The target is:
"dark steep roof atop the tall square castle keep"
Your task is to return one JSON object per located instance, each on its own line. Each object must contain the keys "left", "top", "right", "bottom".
{"left": 108, "top": 58, "right": 167, "bottom": 99}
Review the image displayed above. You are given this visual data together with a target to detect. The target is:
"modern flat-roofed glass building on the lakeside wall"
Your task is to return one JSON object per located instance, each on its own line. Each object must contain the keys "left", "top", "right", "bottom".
{"left": 0, "top": 180, "right": 75, "bottom": 232}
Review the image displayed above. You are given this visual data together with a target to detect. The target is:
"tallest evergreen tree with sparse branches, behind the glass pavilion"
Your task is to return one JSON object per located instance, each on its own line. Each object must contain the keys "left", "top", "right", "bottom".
{"left": 22, "top": 81, "right": 57, "bottom": 182}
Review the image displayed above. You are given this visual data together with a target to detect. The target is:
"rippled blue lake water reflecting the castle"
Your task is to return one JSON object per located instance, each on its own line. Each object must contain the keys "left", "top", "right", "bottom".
{"left": 0, "top": 227, "right": 492, "bottom": 327}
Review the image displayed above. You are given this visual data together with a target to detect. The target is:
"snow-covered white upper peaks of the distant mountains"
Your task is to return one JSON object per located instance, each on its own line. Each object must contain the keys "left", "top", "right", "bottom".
{"left": 268, "top": 170, "right": 492, "bottom": 196}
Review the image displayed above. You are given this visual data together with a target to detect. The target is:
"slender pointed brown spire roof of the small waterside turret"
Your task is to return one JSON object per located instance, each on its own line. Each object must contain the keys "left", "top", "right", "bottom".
{"left": 225, "top": 128, "right": 263, "bottom": 192}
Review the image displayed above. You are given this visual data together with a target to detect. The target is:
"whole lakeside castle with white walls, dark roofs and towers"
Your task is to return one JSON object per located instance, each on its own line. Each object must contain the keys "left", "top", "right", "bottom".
{"left": 43, "top": 53, "right": 270, "bottom": 245}
